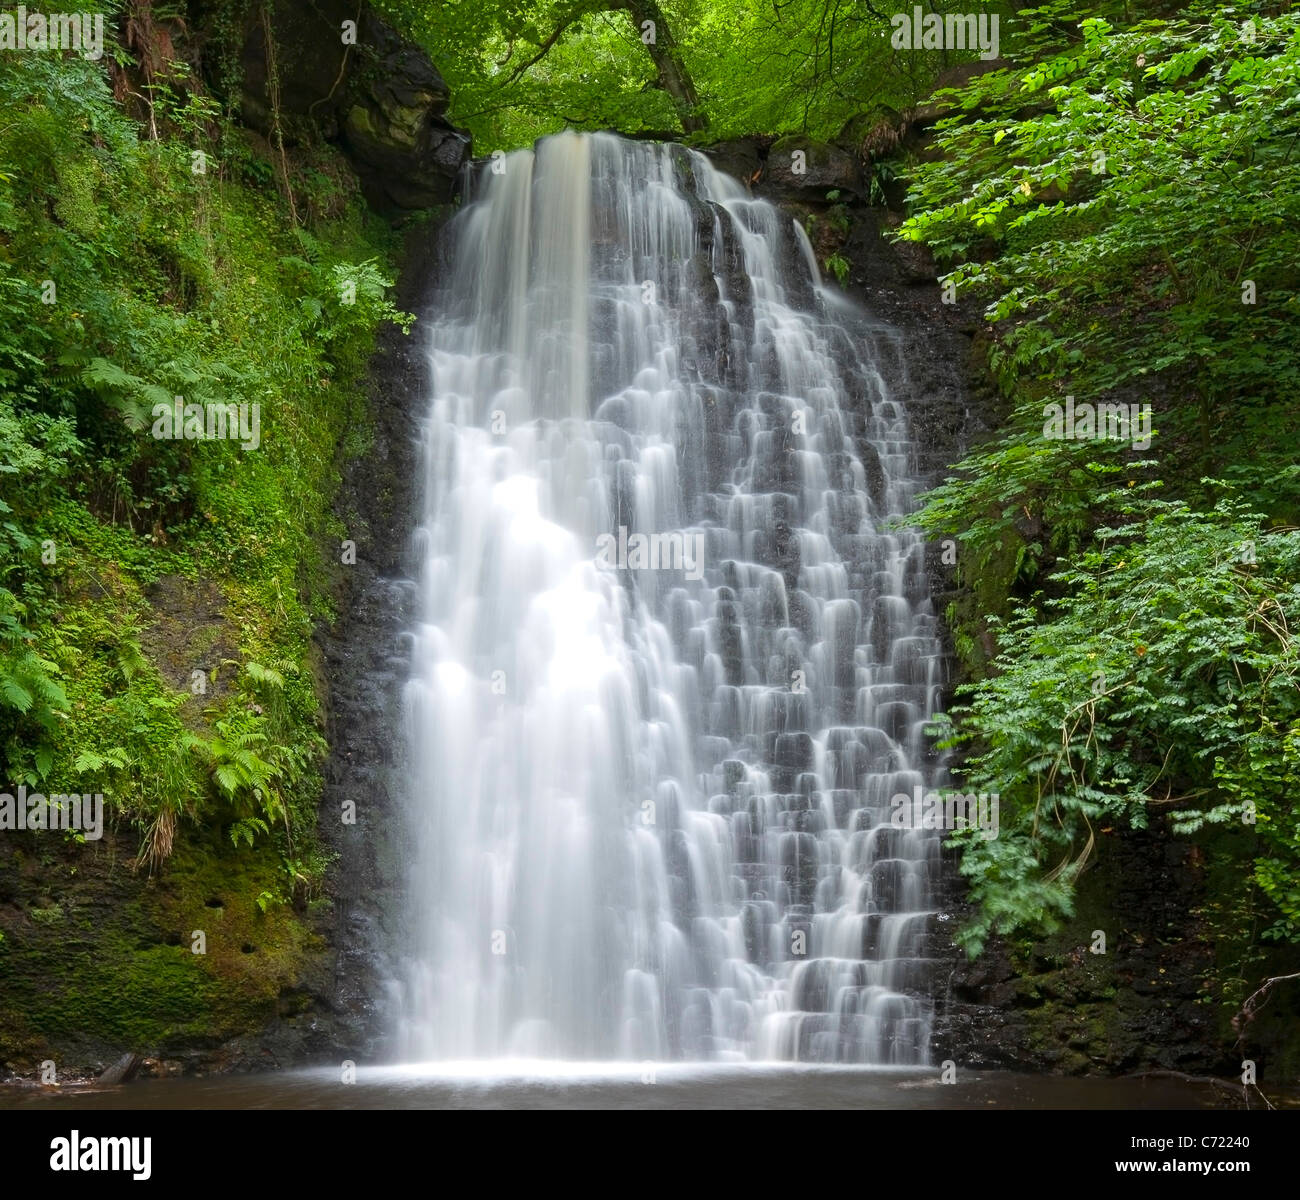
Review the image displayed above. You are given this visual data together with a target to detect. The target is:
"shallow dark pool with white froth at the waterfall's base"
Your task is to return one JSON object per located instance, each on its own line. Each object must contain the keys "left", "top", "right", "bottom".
{"left": 0, "top": 1060, "right": 1242, "bottom": 1110}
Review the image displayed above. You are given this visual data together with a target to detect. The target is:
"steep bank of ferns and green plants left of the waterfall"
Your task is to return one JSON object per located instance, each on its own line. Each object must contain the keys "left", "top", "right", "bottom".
{"left": 0, "top": 14, "right": 397, "bottom": 896}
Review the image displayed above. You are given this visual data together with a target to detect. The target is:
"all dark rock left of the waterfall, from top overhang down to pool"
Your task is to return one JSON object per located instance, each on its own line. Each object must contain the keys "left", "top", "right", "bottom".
{"left": 215, "top": 7, "right": 471, "bottom": 1062}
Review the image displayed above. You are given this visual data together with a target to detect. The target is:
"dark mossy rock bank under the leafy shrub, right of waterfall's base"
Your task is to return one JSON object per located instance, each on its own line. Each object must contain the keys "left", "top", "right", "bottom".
{"left": 932, "top": 829, "right": 1222, "bottom": 1076}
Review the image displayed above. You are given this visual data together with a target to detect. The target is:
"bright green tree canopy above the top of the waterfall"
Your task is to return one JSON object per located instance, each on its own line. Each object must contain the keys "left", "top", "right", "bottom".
{"left": 380, "top": 0, "right": 1008, "bottom": 152}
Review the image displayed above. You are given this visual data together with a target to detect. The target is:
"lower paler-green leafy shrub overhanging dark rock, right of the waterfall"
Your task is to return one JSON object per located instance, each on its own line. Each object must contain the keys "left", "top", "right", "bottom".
{"left": 950, "top": 494, "right": 1300, "bottom": 949}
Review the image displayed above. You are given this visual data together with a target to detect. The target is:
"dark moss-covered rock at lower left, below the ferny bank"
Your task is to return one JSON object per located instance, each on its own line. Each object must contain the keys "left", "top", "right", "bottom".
{"left": 0, "top": 839, "right": 321, "bottom": 1061}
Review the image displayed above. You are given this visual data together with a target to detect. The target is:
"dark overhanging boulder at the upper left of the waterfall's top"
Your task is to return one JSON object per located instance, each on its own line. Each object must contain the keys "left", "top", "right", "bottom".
{"left": 231, "top": 0, "right": 471, "bottom": 212}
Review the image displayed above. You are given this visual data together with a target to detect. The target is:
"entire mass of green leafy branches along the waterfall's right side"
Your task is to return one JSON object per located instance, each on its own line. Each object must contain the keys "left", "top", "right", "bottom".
{"left": 904, "top": 4, "right": 1300, "bottom": 967}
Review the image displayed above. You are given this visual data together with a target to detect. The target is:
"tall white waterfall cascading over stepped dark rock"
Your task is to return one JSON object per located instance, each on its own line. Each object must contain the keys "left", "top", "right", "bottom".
{"left": 398, "top": 134, "right": 944, "bottom": 1065}
